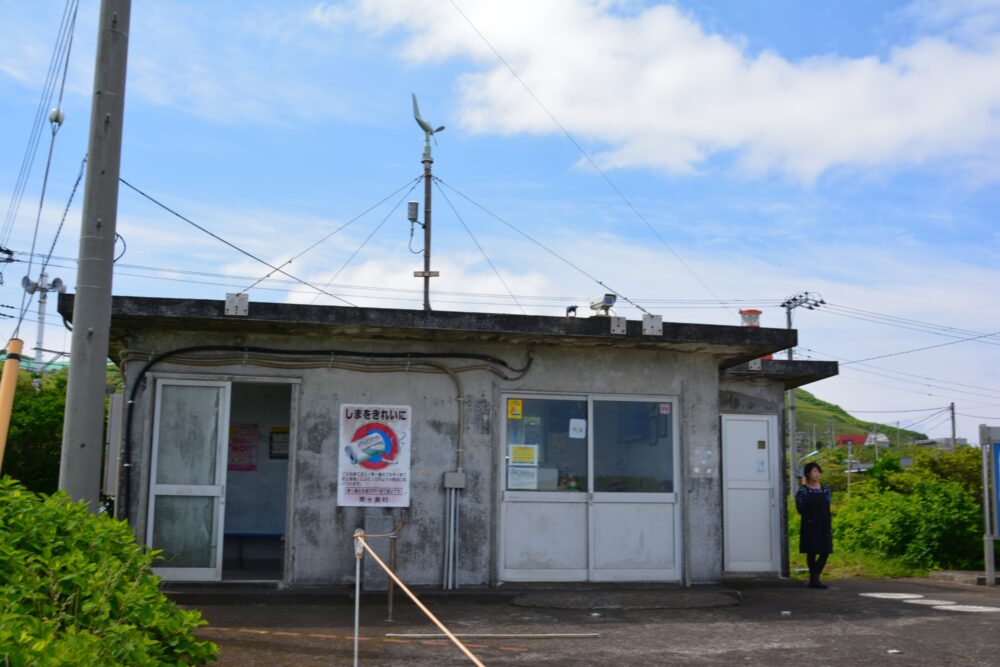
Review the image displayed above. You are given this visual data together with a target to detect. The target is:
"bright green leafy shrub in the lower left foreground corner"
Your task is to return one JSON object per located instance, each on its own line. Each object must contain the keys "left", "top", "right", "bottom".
{"left": 0, "top": 478, "right": 217, "bottom": 666}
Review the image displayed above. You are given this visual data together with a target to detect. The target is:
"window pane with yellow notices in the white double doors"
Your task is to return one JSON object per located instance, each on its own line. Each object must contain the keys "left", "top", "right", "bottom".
{"left": 506, "top": 396, "right": 589, "bottom": 491}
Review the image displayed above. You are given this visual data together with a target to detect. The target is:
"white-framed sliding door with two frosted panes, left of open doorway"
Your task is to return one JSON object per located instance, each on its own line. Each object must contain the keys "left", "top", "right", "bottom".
{"left": 146, "top": 379, "right": 230, "bottom": 581}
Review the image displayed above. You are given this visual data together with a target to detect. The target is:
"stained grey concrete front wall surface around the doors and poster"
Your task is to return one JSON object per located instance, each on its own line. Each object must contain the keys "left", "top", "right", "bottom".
{"left": 126, "top": 333, "right": 722, "bottom": 587}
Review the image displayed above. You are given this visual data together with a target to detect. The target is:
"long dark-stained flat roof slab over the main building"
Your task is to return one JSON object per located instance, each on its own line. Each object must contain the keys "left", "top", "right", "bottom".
{"left": 59, "top": 294, "right": 797, "bottom": 369}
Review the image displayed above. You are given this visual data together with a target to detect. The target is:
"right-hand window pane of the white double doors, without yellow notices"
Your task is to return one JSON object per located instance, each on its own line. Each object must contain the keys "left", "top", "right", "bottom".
{"left": 594, "top": 401, "right": 674, "bottom": 493}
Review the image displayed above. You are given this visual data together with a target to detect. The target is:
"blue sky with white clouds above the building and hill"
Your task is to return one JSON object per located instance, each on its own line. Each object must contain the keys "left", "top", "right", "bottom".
{"left": 0, "top": 0, "right": 1000, "bottom": 440}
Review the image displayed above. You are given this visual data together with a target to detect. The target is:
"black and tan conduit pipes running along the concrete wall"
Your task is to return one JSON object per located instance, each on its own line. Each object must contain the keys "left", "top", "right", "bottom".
{"left": 116, "top": 345, "right": 532, "bottom": 589}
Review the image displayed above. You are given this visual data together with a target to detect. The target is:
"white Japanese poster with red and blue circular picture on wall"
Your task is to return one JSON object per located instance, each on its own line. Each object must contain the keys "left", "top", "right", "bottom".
{"left": 337, "top": 404, "right": 413, "bottom": 507}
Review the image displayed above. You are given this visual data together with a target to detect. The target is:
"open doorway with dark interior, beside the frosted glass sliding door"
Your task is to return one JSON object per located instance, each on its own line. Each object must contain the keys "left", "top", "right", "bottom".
{"left": 222, "top": 382, "right": 292, "bottom": 580}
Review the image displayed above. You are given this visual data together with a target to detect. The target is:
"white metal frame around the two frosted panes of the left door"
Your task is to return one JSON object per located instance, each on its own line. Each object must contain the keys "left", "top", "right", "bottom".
{"left": 146, "top": 377, "right": 232, "bottom": 581}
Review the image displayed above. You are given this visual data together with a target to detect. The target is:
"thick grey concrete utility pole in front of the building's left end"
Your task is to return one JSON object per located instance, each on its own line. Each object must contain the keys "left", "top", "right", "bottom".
{"left": 59, "top": 0, "right": 131, "bottom": 512}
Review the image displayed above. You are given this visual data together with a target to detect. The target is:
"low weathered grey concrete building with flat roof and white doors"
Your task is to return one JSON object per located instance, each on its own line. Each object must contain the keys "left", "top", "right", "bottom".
{"left": 59, "top": 295, "right": 837, "bottom": 588}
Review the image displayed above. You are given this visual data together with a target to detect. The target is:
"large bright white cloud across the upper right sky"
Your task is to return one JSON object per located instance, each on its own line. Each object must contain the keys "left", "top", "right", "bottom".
{"left": 330, "top": 0, "right": 1000, "bottom": 182}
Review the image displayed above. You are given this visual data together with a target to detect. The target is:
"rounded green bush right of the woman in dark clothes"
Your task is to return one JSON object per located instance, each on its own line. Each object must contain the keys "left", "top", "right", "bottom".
{"left": 833, "top": 479, "right": 982, "bottom": 569}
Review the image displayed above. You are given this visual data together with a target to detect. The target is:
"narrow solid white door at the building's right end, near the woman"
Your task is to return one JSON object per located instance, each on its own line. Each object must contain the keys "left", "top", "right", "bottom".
{"left": 722, "top": 415, "right": 781, "bottom": 572}
